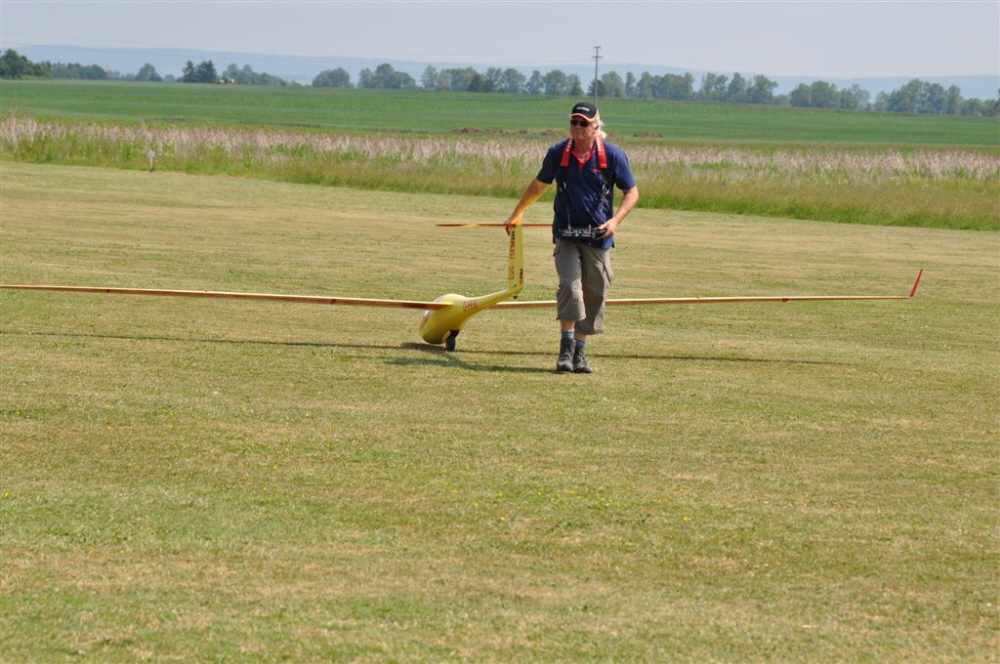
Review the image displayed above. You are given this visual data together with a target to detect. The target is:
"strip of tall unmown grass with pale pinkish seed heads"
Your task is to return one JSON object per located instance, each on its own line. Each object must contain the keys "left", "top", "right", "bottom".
{"left": 0, "top": 116, "right": 1000, "bottom": 230}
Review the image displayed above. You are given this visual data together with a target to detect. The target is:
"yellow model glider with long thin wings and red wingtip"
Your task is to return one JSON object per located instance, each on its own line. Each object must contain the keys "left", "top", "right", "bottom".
{"left": 0, "top": 224, "right": 923, "bottom": 350}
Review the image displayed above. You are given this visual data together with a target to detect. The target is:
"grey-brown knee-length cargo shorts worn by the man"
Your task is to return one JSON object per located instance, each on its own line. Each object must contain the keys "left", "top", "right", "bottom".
{"left": 552, "top": 239, "right": 614, "bottom": 335}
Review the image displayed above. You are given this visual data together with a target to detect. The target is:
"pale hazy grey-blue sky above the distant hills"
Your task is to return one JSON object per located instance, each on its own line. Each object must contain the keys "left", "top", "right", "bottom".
{"left": 0, "top": 0, "right": 1000, "bottom": 77}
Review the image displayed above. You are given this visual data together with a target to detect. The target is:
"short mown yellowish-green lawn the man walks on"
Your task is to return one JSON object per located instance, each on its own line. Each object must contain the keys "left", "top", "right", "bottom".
{"left": 0, "top": 162, "right": 1000, "bottom": 662}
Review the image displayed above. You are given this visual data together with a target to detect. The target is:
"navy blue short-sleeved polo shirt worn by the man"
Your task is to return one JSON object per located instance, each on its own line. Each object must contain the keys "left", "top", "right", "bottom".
{"left": 535, "top": 139, "right": 635, "bottom": 249}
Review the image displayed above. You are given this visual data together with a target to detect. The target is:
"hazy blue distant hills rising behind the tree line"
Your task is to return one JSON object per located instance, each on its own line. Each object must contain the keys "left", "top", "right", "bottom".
{"left": 15, "top": 45, "right": 1000, "bottom": 99}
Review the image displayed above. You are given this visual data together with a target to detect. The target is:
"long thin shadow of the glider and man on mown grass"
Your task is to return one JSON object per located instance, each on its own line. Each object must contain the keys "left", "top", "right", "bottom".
{"left": 0, "top": 330, "right": 847, "bottom": 373}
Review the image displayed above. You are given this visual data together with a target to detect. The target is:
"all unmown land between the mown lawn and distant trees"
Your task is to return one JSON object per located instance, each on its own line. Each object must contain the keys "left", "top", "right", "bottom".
{"left": 0, "top": 81, "right": 1000, "bottom": 230}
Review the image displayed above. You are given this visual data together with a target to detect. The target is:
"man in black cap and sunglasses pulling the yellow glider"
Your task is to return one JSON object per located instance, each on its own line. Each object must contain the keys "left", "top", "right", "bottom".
{"left": 504, "top": 102, "right": 639, "bottom": 373}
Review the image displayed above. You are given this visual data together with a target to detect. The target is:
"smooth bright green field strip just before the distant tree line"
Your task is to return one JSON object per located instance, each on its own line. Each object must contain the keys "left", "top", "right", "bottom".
{"left": 0, "top": 81, "right": 1000, "bottom": 146}
